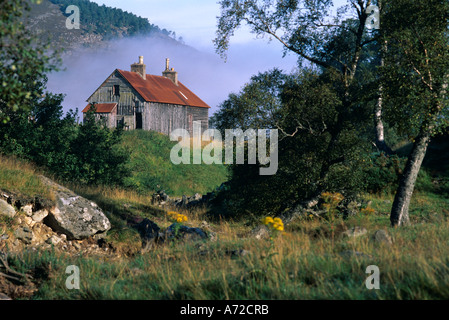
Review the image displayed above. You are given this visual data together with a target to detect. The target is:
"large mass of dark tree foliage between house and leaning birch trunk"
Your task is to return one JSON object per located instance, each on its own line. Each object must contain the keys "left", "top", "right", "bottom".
{"left": 214, "top": 0, "right": 396, "bottom": 220}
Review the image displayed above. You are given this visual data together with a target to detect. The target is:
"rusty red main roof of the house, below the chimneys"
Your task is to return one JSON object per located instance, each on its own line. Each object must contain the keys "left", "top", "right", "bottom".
{"left": 117, "top": 69, "right": 210, "bottom": 108}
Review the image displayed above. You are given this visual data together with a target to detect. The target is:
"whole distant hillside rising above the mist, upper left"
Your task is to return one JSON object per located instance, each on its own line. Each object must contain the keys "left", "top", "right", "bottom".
{"left": 24, "top": 0, "right": 176, "bottom": 51}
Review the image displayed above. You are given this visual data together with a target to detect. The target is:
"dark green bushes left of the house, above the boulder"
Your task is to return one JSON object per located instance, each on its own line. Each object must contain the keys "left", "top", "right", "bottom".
{"left": 0, "top": 94, "right": 129, "bottom": 185}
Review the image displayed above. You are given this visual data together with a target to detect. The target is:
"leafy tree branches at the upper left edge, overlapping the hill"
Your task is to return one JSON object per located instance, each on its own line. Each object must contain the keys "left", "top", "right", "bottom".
{"left": 0, "top": 0, "right": 57, "bottom": 122}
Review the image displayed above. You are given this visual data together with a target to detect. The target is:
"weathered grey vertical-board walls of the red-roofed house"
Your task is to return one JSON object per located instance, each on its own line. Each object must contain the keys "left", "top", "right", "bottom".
{"left": 88, "top": 71, "right": 209, "bottom": 135}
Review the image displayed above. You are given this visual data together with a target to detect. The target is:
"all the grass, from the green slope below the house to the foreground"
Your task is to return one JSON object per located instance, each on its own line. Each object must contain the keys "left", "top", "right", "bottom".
{"left": 0, "top": 131, "right": 449, "bottom": 300}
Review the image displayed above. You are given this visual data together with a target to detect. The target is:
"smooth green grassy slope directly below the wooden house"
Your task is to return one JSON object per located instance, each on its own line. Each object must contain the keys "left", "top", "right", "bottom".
{"left": 123, "top": 130, "right": 227, "bottom": 196}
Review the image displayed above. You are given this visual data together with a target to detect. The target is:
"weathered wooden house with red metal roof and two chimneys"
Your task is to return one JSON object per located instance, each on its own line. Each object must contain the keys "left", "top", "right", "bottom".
{"left": 83, "top": 56, "right": 210, "bottom": 135}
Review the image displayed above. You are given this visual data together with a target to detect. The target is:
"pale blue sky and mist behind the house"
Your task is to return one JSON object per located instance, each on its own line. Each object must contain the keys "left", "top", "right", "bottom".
{"left": 47, "top": 0, "right": 346, "bottom": 116}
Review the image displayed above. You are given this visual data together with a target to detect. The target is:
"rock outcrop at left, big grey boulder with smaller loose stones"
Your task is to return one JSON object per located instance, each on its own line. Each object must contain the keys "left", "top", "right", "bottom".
{"left": 0, "top": 176, "right": 111, "bottom": 252}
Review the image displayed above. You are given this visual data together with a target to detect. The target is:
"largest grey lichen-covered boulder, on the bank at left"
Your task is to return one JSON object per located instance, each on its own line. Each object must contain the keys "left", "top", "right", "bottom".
{"left": 42, "top": 177, "right": 111, "bottom": 240}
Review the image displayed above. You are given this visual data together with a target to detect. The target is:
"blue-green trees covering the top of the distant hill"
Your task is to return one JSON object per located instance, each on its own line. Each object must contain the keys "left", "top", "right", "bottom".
{"left": 50, "top": 0, "right": 172, "bottom": 38}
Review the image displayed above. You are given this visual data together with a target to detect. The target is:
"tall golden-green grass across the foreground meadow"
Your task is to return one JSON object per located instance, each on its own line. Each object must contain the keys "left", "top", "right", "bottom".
{"left": 6, "top": 190, "right": 449, "bottom": 300}
